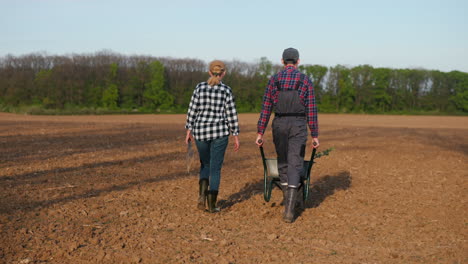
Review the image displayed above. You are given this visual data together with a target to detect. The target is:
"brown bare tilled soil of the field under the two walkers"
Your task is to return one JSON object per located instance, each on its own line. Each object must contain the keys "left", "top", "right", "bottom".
{"left": 0, "top": 113, "right": 468, "bottom": 263}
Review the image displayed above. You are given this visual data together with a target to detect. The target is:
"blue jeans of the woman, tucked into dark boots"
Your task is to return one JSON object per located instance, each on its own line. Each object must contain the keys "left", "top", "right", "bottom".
{"left": 195, "top": 136, "right": 229, "bottom": 191}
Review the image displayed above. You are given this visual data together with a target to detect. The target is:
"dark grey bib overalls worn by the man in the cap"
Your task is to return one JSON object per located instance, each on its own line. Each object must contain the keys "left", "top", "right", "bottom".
{"left": 272, "top": 74, "right": 307, "bottom": 188}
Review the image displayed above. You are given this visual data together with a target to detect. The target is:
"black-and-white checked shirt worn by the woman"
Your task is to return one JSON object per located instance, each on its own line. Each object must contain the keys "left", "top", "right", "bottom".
{"left": 185, "top": 82, "right": 239, "bottom": 141}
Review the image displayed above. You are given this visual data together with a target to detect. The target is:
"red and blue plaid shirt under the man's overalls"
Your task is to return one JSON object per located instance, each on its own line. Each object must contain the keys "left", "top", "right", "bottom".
{"left": 257, "top": 66, "right": 318, "bottom": 138}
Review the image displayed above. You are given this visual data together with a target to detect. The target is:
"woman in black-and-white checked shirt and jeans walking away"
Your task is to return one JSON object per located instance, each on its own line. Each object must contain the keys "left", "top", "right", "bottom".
{"left": 185, "top": 60, "right": 239, "bottom": 213}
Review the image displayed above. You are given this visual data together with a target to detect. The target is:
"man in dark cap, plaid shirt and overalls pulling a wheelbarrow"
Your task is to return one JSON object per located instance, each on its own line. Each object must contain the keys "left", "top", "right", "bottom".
{"left": 255, "top": 48, "right": 320, "bottom": 223}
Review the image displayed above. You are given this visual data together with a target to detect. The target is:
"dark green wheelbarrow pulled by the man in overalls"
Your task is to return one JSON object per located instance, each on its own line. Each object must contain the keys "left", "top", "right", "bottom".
{"left": 260, "top": 142, "right": 333, "bottom": 202}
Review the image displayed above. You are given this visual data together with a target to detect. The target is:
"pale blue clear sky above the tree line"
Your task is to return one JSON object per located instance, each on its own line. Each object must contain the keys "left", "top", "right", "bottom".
{"left": 0, "top": 0, "right": 468, "bottom": 72}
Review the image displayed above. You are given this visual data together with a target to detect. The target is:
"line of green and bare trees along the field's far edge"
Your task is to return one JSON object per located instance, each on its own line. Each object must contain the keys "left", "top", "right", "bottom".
{"left": 0, "top": 51, "right": 468, "bottom": 114}
